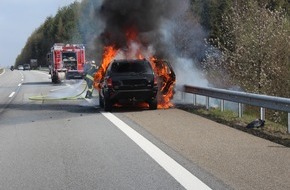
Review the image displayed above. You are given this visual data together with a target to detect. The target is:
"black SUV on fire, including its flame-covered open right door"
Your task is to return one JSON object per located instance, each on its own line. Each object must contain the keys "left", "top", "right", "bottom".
{"left": 98, "top": 59, "right": 175, "bottom": 111}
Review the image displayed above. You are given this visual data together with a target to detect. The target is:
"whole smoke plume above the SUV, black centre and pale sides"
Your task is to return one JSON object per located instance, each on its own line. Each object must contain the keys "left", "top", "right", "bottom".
{"left": 81, "top": 0, "right": 207, "bottom": 86}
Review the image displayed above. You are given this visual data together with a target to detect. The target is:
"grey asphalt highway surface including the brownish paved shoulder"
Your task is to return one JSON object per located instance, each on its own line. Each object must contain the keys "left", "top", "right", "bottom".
{"left": 0, "top": 70, "right": 290, "bottom": 190}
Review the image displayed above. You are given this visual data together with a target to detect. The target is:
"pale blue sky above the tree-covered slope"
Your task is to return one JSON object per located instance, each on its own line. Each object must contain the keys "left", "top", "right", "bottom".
{"left": 0, "top": 0, "right": 80, "bottom": 67}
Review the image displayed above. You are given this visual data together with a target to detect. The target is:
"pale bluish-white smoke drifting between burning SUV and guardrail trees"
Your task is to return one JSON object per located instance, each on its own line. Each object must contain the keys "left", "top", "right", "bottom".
{"left": 160, "top": 6, "right": 209, "bottom": 87}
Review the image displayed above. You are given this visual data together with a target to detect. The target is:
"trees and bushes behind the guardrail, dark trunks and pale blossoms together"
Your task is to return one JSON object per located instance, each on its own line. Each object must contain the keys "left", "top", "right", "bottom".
{"left": 195, "top": 0, "right": 290, "bottom": 123}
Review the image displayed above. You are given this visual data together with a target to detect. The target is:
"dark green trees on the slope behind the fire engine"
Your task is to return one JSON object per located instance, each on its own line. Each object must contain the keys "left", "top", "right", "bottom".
{"left": 14, "top": 2, "right": 83, "bottom": 66}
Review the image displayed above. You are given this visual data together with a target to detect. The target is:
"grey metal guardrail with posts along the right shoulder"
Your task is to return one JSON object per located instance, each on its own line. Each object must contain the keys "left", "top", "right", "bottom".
{"left": 180, "top": 85, "right": 290, "bottom": 133}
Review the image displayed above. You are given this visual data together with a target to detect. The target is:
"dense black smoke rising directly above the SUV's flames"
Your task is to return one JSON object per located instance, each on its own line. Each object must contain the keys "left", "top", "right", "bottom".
{"left": 99, "top": 0, "right": 184, "bottom": 48}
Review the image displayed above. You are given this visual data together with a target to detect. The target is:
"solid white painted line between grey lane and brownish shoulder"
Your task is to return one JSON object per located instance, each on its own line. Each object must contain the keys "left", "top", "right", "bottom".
{"left": 101, "top": 112, "right": 211, "bottom": 190}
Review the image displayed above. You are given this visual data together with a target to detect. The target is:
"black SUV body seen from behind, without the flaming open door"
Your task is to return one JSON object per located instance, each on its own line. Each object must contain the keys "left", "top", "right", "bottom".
{"left": 99, "top": 59, "right": 158, "bottom": 111}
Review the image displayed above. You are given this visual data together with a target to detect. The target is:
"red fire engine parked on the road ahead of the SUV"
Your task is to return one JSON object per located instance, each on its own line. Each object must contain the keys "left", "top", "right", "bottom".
{"left": 48, "top": 43, "right": 85, "bottom": 83}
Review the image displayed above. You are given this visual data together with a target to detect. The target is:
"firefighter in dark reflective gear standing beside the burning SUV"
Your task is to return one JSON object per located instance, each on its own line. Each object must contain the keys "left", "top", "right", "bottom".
{"left": 84, "top": 61, "right": 97, "bottom": 99}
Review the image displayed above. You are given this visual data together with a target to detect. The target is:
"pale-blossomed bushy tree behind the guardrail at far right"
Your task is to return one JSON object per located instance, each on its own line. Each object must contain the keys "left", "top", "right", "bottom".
{"left": 205, "top": 2, "right": 290, "bottom": 97}
